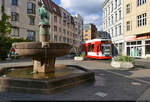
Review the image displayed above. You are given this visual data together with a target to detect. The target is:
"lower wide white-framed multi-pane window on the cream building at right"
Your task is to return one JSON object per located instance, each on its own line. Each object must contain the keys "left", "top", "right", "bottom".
{"left": 137, "top": 13, "right": 147, "bottom": 27}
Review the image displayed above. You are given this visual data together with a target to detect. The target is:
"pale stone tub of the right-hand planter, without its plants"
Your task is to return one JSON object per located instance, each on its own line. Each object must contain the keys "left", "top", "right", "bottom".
{"left": 111, "top": 61, "right": 134, "bottom": 69}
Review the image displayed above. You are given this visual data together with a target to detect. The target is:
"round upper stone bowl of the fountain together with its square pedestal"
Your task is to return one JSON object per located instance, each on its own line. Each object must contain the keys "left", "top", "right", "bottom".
{"left": 13, "top": 42, "right": 72, "bottom": 73}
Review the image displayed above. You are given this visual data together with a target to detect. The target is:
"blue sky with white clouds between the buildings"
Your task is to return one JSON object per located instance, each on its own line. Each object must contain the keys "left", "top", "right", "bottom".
{"left": 53, "top": 0, "right": 104, "bottom": 30}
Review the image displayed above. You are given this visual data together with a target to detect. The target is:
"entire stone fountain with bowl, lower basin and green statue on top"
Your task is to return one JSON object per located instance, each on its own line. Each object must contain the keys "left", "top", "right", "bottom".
{"left": 0, "top": 5, "right": 95, "bottom": 94}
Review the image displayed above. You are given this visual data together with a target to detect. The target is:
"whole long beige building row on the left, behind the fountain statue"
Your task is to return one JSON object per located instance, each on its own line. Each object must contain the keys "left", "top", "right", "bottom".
{"left": 0, "top": 0, "right": 83, "bottom": 52}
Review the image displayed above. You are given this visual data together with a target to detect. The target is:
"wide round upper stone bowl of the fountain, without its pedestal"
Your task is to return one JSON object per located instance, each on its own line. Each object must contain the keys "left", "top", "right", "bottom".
{"left": 12, "top": 42, "right": 72, "bottom": 58}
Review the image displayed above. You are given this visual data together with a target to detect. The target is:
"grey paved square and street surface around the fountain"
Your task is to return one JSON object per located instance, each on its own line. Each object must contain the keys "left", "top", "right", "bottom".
{"left": 0, "top": 59, "right": 150, "bottom": 101}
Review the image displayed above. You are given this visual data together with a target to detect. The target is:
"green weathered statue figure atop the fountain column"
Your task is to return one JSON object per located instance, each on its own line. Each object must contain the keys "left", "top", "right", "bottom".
{"left": 39, "top": 4, "right": 49, "bottom": 25}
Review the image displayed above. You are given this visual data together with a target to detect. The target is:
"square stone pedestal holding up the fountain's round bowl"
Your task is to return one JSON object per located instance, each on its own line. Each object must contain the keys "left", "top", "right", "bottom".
{"left": 33, "top": 57, "right": 56, "bottom": 73}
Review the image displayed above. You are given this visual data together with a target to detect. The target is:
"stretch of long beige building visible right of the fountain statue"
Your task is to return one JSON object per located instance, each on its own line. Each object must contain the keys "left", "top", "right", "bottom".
{"left": 43, "top": 0, "right": 83, "bottom": 50}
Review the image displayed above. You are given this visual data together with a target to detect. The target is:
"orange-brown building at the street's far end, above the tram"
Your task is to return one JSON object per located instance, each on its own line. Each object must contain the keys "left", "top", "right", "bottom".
{"left": 83, "top": 24, "right": 98, "bottom": 41}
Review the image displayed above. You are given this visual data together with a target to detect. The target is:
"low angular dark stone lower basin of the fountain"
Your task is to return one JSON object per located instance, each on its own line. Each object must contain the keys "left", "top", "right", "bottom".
{"left": 0, "top": 65, "right": 95, "bottom": 94}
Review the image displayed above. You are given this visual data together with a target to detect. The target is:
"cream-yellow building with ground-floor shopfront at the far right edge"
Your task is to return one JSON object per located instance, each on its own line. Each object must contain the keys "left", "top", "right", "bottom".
{"left": 124, "top": 0, "right": 150, "bottom": 57}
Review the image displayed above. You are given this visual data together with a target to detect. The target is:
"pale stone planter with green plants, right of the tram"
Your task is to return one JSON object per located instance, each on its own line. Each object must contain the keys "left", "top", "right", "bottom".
{"left": 111, "top": 56, "right": 135, "bottom": 69}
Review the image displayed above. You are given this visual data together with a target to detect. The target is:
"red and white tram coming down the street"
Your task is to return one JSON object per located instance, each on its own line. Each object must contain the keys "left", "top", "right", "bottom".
{"left": 82, "top": 39, "right": 112, "bottom": 59}
